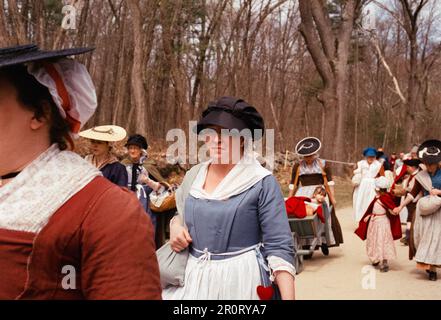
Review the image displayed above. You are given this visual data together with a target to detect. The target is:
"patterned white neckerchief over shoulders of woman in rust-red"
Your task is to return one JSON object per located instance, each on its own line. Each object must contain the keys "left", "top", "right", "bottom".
{"left": 0, "top": 144, "right": 102, "bottom": 233}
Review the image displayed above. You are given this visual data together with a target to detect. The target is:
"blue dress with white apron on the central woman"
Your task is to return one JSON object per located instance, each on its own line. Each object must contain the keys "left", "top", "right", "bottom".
{"left": 163, "top": 175, "right": 295, "bottom": 299}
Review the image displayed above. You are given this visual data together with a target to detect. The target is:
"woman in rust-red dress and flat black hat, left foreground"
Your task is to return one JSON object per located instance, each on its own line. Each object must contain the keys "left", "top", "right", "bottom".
{"left": 0, "top": 45, "right": 161, "bottom": 300}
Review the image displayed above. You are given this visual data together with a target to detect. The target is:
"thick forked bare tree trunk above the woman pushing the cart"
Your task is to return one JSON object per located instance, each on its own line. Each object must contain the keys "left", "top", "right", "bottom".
{"left": 299, "top": 0, "right": 364, "bottom": 159}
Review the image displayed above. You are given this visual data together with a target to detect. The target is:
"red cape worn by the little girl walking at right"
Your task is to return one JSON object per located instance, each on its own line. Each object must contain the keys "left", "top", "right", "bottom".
{"left": 355, "top": 194, "right": 402, "bottom": 240}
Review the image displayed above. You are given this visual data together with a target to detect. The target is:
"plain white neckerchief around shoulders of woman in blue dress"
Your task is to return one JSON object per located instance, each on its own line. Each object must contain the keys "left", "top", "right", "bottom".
{"left": 190, "top": 153, "right": 271, "bottom": 200}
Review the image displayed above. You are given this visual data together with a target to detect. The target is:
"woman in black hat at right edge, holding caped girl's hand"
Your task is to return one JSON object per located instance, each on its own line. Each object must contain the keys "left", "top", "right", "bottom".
{"left": 394, "top": 140, "right": 441, "bottom": 281}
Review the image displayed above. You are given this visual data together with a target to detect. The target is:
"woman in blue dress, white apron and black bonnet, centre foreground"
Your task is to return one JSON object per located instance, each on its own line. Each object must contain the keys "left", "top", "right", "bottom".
{"left": 163, "top": 97, "right": 295, "bottom": 300}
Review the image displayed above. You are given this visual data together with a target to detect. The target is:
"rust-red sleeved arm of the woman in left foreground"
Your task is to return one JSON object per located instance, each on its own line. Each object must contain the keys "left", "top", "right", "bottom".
{"left": 79, "top": 187, "right": 161, "bottom": 300}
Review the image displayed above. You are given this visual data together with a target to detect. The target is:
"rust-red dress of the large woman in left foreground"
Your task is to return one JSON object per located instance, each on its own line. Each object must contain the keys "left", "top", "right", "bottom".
{"left": 0, "top": 177, "right": 161, "bottom": 299}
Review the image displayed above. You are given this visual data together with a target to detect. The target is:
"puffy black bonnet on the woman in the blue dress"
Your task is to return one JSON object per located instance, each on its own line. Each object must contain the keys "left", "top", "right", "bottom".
{"left": 195, "top": 97, "right": 265, "bottom": 139}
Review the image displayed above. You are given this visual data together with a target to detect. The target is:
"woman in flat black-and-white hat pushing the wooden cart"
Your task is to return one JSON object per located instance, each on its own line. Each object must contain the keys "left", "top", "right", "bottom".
{"left": 289, "top": 137, "right": 343, "bottom": 255}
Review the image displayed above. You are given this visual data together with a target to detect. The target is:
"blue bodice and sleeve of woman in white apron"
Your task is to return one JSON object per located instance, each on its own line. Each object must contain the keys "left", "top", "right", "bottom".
{"left": 185, "top": 176, "right": 294, "bottom": 263}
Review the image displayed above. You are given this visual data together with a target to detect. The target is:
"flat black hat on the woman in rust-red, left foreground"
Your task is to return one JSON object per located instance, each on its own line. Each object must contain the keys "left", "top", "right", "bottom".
{"left": 0, "top": 44, "right": 95, "bottom": 68}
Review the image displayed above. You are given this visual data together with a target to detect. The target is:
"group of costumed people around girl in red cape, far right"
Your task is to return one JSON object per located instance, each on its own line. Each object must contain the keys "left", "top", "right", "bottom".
{"left": 352, "top": 140, "right": 441, "bottom": 281}
